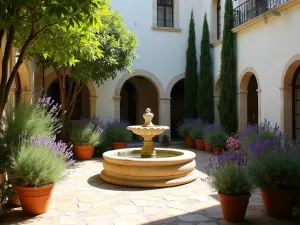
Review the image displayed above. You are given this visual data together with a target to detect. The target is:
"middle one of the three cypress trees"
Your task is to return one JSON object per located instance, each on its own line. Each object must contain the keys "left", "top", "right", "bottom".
{"left": 197, "top": 14, "right": 214, "bottom": 123}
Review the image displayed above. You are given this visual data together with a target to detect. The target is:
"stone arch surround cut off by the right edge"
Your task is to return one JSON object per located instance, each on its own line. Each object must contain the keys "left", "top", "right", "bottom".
{"left": 279, "top": 54, "right": 300, "bottom": 136}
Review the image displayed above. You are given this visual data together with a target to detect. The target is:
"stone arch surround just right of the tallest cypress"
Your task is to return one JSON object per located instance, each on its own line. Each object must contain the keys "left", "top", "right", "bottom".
{"left": 238, "top": 67, "right": 261, "bottom": 129}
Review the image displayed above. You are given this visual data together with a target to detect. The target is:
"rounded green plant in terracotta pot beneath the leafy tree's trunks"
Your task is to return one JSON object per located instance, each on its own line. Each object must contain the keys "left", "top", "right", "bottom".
{"left": 70, "top": 123, "right": 103, "bottom": 146}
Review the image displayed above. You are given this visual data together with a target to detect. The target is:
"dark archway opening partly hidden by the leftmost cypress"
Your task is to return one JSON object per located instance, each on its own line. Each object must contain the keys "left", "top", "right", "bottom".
{"left": 171, "top": 78, "right": 184, "bottom": 138}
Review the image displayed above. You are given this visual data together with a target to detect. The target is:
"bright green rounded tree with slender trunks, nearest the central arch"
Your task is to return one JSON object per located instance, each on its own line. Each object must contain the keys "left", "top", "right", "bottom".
{"left": 29, "top": 8, "right": 137, "bottom": 139}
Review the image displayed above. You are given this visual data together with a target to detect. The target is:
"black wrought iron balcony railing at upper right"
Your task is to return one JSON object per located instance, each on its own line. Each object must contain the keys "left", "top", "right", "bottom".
{"left": 233, "top": 0, "right": 289, "bottom": 27}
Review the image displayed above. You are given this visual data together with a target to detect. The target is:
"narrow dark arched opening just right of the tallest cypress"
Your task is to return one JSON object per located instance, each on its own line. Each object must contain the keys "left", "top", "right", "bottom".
{"left": 247, "top": 74, "right": 258, "bottom": 124}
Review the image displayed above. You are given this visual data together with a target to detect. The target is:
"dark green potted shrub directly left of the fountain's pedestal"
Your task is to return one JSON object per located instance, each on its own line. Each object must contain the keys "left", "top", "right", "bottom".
{"left": 105, "top": 126, "right": 132, "bottom": 142}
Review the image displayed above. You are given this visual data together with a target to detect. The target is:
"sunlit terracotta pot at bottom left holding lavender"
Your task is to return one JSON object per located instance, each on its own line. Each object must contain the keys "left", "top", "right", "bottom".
{"left": 16, "top": 183, "right": 54, "bottom": 215}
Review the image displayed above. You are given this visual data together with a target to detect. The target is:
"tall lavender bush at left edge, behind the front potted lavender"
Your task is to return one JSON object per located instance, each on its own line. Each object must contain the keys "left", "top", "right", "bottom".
{"left": 0, "top": 95, "right": 61, "bottom": 171}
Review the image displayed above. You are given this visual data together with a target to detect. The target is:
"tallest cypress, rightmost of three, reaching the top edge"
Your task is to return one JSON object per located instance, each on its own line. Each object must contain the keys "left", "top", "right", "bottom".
{"left": 219, "top": 0, "right": 238, "bottom": 133}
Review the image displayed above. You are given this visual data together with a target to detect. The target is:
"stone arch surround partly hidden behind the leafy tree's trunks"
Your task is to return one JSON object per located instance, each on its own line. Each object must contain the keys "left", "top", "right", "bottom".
{"left": 44, "top": 70, "right": 98, "bottom": 117}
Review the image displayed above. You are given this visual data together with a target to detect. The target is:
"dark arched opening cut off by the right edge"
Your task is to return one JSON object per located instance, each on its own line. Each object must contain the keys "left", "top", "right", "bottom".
{"left": 293, "top": 66, "right": 300, "bottom": 138}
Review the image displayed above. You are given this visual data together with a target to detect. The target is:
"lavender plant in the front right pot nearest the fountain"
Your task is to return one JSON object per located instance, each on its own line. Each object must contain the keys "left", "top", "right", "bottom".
{"left": 202, "top": 151, "right": 255, "bottom": 196}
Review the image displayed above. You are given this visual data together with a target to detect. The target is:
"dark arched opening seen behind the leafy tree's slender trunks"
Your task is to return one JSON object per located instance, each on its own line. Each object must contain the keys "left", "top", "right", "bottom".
{"left": 47, "top": 79, "right": 91, "bottom": 120}
